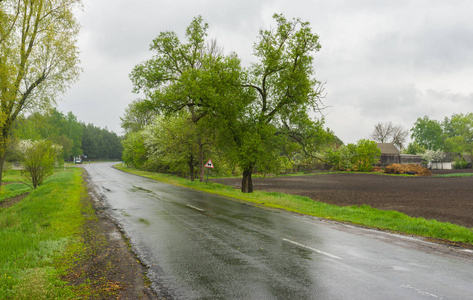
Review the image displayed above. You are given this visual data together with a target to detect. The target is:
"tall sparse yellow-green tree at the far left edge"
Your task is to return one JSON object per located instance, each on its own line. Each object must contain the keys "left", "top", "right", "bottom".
{"left": 0, "top": 0, "right": 81, "bottom": 188}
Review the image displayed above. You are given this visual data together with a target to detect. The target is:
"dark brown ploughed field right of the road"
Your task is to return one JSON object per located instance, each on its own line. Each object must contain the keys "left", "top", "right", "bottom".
{"left": 214, "top": 169, "right": 473, "bottom": 228}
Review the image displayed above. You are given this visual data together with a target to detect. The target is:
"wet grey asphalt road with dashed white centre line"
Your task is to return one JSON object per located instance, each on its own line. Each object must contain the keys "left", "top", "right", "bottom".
{"left": 84, "top": 163, "right": 473, "bottom": 299}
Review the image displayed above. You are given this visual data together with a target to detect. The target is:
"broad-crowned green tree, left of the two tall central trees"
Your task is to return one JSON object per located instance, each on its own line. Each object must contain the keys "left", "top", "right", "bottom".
{"left": 128, "top": 17, "right": 241, "bottom": 181}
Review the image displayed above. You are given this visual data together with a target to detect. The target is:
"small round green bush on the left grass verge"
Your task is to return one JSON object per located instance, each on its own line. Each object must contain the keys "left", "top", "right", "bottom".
{"left": 18, "top": 140, "right": 62, "bottom": 188}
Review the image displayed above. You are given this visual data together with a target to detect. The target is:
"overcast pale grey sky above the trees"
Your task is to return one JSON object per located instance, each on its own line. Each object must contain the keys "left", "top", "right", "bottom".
{"left": 59, "top": 0, "right": 473, "bottom": 143}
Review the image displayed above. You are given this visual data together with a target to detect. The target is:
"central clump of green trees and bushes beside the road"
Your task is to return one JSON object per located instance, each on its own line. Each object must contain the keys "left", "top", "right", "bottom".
{"left": 122, "top": 15, "right": 336, "bottom": 192}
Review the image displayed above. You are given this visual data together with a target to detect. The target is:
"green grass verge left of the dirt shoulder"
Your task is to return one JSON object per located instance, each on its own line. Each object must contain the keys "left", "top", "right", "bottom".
{"left": 0, "top": 168, "right": 93, "bottom": 299}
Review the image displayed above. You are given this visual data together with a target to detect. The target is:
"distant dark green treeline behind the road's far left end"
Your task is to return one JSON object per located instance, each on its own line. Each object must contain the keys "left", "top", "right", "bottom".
{"left": 10, "top": 109, "right": 122, "bottom": 161}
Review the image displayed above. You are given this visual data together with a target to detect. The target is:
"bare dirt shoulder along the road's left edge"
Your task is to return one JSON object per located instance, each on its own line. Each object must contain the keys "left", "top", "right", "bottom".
{"left": 59, "top": 172, "right": 157, "bottom": 300}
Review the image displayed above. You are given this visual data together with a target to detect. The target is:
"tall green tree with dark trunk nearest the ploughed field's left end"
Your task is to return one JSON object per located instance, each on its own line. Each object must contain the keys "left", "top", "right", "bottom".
{"left": 232, "top": 14, "right": 322, "bottom": 193}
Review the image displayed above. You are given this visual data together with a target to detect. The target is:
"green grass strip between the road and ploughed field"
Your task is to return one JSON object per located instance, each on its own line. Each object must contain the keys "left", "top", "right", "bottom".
{"left": 116, "top": 166, "right": 473, "bottom": 244}
